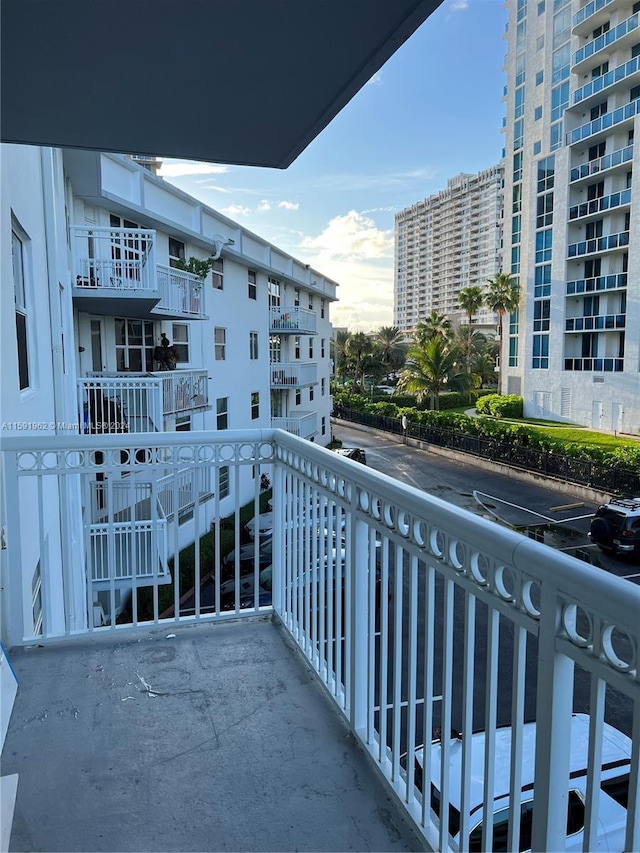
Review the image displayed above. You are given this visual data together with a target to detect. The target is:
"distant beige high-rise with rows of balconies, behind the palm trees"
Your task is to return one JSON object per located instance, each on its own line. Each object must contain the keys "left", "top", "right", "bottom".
{"left": 393, "top": 163, "right": 504, "bottom": 333}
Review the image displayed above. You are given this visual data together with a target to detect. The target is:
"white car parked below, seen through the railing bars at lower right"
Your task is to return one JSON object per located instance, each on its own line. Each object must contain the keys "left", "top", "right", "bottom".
{"left": 401, "top": 714, "right": 631, "bottom": 853}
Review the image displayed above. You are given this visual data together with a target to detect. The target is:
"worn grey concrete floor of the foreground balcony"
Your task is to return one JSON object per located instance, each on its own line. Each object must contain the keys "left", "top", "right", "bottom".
{"left": 2, "top": 619, "right": 423, "bottom": 851}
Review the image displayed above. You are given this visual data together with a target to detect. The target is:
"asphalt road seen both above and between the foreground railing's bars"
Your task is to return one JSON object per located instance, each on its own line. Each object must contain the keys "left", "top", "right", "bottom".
{"left": 333, "top": 421, "right": 640, "bottom": 748}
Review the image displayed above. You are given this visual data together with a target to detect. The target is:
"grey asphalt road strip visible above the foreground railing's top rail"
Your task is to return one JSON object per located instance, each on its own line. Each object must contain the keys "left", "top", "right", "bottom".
{"left": 332, "top": 421, "right": 640, "bottom": 583}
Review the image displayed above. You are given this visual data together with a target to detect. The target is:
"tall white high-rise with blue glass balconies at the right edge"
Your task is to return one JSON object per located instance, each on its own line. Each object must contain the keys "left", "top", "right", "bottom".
{"left": 502, "top": 0, "right": 640, "bottom": 432}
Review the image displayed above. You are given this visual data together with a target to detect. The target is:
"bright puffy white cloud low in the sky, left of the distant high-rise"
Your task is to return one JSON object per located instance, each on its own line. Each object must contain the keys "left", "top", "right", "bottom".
{"left": 302, "top": 210, "right": 393, "bottom": 260}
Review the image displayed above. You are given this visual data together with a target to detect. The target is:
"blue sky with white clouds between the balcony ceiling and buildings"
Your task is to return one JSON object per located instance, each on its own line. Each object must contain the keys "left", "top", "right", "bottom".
{"left": 160, "top": 0, "right": 507, "bottom": 332}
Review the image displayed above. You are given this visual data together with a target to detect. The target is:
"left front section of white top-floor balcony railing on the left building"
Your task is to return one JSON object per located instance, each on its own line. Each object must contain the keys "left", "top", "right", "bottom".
{"left": 69, "top": 226, "right": 158, "bottom": 294}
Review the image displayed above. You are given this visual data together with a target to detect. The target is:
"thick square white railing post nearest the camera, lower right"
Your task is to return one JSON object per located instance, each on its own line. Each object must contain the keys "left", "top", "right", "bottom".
{"left": 532, "top": 583, "right": 574, "bottom": 850}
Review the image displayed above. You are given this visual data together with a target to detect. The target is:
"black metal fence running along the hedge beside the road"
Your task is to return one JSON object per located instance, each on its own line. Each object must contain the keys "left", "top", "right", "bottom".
{"left": 334, "top": 408, "right": 640, "bottom": 496}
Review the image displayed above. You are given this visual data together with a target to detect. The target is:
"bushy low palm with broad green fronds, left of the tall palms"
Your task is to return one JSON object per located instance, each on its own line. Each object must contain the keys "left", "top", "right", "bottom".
{"left": 398, "top": 336, "right": 471, "bottom": 411}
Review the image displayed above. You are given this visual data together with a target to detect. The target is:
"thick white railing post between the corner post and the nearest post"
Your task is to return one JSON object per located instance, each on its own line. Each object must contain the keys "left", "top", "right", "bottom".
{"left": 348, "top": 514, "right": 368, "bottom": 732}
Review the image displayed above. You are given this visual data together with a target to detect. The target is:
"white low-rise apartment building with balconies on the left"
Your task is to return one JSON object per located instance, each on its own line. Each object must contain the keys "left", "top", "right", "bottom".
{"left": 0, "top": 145, "right": 337, "bottom": 627}
